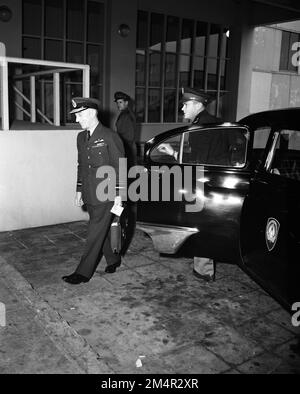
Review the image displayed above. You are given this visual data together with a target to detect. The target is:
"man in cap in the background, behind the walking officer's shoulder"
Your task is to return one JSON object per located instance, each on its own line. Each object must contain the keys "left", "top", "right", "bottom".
{"left": 114, "top": 92, "right": 136, "bottom": 168}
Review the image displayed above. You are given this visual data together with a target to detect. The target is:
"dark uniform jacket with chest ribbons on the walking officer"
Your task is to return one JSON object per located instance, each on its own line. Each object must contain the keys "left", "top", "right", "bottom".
{"left": 76, "top": 123, "right": 125, "bottom": 205}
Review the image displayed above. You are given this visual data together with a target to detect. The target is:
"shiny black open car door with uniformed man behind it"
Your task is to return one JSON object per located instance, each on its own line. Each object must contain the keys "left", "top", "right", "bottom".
{"left": 138, "top": 124, "right": 250, "bottom": 262}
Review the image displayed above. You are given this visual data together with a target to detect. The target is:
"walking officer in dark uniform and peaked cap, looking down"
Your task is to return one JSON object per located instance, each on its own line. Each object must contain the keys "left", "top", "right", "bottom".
{"left": 62, "top": 97, "right": 124, "bottom": 284}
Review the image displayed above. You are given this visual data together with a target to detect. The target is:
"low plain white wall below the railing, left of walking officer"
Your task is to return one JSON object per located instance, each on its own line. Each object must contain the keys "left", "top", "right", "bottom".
{"left": 0, "top": 130, "right": 87, "bottom": 231}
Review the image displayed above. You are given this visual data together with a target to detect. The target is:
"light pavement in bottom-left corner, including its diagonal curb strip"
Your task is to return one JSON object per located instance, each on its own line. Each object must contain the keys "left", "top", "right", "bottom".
{"left": 0, "top": 258, "right": 112, "bottom": 374}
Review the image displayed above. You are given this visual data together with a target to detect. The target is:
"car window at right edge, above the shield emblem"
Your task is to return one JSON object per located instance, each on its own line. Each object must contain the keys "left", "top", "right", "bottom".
{"left": 270, "top": 130, "right": 300, "bottom": 181}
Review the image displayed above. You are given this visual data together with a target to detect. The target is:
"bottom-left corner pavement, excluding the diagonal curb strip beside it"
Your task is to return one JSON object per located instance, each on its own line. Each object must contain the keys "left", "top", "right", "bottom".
{"left": 0, "top": 262, "right": 82, "bottom": 374}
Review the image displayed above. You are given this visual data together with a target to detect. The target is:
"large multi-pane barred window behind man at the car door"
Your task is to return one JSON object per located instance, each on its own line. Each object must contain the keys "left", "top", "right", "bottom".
{"left": 135, "top": 11, "right": 229, "bottom": 123}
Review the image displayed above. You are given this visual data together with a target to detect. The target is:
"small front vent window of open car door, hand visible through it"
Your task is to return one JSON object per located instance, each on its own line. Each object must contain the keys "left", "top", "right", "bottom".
{"left": 150, "top": 134, "right": 182, "bottom": 164}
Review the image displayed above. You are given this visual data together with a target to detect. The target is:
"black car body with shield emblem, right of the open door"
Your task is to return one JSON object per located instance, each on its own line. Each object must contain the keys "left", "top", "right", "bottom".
{"left": 240, "top": 127, "right": 300, "bottom": 311}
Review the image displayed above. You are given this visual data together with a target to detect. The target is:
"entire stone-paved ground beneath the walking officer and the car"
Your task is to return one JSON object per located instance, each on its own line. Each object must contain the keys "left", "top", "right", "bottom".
{"left": 0, "top": 222, "right": 300, "bottom": 374}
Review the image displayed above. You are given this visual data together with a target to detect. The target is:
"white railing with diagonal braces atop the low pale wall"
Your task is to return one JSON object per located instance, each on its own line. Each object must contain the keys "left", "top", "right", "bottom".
{"left": 0, "top": 56, "right": 90, "bottom": 130}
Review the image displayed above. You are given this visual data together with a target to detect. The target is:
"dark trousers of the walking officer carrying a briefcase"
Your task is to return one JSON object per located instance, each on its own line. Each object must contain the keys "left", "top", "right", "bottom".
{"left": 75, "top": 201, "right": 121, "bottom": 279}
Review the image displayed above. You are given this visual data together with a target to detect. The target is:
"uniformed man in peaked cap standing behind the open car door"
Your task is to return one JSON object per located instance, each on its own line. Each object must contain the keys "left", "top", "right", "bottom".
{"left": 160, "top": 88, "right": 222, "bottom": 282}
